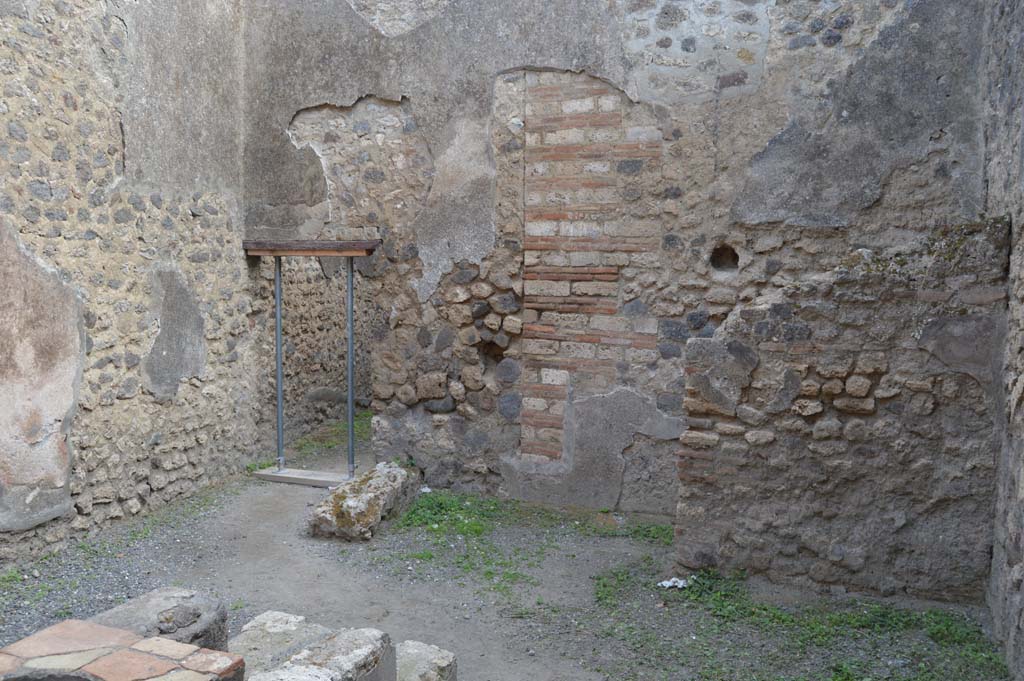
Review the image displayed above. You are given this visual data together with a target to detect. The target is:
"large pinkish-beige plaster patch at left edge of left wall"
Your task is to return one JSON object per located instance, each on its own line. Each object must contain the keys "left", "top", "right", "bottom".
{"left": 0, "top": 224, "right": 85, "bottom": 531}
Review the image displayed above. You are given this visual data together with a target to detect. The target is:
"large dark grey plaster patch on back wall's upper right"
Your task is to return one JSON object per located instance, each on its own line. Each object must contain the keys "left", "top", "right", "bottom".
{"left": 732, "top": 1, "right": 983, "bottom": 227}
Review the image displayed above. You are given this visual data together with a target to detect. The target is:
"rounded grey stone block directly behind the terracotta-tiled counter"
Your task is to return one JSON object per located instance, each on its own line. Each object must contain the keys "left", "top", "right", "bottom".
{"left": 90, "top": 588, "right": 227, "bottom": 650}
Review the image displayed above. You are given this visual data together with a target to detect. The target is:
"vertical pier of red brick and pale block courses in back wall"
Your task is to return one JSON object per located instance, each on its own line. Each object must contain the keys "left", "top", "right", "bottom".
{"left": 518, "top": 70, "right": 662, "bottom": 459}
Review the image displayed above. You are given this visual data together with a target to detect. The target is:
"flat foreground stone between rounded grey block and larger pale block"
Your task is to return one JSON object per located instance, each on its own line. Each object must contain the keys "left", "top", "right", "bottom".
{"left": 227, "top": 610, "right": 333, "bottom": 681}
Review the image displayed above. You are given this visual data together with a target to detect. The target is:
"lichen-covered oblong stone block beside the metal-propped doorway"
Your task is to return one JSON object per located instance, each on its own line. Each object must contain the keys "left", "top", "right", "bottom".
{"left": 309, "top": 463, "right": 420, "bottom": 542}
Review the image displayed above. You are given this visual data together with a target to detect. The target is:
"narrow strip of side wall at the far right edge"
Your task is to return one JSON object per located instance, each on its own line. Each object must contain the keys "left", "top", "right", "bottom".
{"left": 985, "top": 2, "right": 1024, "bottom": 678}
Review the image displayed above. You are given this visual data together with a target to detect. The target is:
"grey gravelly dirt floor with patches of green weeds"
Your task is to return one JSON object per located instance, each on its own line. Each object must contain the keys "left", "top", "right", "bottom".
{"left": 0, "top": 421, "right": 1007, "bottom": 681}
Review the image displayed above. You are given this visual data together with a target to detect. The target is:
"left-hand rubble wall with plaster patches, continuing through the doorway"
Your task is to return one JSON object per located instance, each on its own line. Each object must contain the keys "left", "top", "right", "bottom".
{"left": 0, "top": 0, "right": 352, "bottom": 559}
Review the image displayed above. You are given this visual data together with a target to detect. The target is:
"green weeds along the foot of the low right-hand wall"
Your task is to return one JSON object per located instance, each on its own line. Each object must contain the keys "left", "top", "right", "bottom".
{"left": 594, "top": 558, "right": 1008, "bottom": 681}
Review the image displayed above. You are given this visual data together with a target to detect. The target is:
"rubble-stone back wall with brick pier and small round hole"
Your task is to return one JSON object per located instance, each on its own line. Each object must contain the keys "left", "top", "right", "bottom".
{"left": 237, "top": 0, "right": 1009, "bottom": 585}
